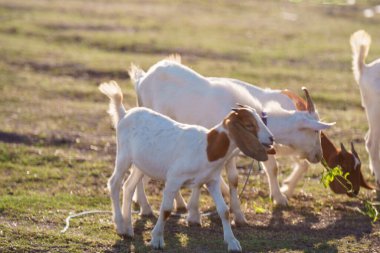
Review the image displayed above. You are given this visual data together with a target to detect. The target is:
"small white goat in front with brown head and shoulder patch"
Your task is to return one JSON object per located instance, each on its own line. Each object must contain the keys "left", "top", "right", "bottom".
{"left": 99, "top": 82, "right": 273, "bottom": 252}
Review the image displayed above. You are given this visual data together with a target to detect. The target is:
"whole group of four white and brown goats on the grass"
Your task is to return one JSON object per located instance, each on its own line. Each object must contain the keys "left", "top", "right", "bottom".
{"left": 99, "top": 31, "right": 380, "bottom": 252}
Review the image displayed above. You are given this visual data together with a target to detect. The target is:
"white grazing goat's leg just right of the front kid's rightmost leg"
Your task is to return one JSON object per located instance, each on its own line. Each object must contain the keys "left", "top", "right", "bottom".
{"left": 226, "top": 158, "right": 247, "bottom": 226}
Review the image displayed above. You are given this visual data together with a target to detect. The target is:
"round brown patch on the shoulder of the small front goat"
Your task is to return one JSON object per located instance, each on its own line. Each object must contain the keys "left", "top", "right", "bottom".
{"left": 207, "top": 129, "right": 230, "bottom": 162}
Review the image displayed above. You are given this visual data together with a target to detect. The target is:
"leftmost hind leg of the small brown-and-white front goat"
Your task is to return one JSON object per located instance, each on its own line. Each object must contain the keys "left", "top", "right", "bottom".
{"left": 108, "top": 154, "right": 131, "bottom": 236}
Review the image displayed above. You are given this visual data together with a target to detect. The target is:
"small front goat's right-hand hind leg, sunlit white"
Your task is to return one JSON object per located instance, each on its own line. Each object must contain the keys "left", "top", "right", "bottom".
{"left": 123, "top": 167, "right": 144, "bottom": 237}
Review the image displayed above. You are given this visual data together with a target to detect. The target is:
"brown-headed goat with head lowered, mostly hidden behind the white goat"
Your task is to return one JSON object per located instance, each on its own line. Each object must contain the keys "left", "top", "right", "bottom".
{"left": 276, "top": 90, "right": 374, "bottom": 197}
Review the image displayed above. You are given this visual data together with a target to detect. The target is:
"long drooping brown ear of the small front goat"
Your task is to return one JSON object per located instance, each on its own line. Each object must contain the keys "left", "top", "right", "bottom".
{"left": 228, "top": 121, "right": 268, "bottom": 161}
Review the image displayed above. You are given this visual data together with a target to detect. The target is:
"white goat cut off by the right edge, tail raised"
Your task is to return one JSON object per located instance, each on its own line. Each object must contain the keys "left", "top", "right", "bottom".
{"left": 350, "top": 30, "right": 380, "bottom": 186}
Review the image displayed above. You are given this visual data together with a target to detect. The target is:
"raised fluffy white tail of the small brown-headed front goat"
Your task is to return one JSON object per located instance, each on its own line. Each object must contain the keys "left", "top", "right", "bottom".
{"left": 99, "top": 81, "right": 127, "bottom": 128}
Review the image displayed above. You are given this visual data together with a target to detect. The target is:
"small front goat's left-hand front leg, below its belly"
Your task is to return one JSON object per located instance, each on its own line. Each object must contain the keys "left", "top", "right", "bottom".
{"left": 150, "top": 179, "right": 182, "bottom": 249}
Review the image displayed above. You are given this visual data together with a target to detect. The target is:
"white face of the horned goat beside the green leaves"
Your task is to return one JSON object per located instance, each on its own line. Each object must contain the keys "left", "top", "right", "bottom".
{"left": 290, "top": 111, "right": 334, "bottom": 163}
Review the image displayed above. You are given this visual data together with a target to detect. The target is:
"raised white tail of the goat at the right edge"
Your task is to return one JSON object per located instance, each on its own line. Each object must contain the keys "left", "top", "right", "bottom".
{"left": 350, "top": 30, "right": 371, "bottom": 83}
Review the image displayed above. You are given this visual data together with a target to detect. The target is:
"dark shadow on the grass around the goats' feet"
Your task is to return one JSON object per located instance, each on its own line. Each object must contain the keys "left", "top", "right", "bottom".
{"left": 112, "top": 203, "right": 373, "bottom": 253}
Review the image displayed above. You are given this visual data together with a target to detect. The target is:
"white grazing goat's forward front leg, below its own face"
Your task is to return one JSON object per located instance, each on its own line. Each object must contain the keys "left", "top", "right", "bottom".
{"left": 263, "top": 155, "right": 288, "bottom": 206}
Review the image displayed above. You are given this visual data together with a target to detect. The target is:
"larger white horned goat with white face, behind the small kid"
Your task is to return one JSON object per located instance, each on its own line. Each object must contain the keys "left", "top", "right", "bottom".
{"left": 130, "top": 59, "right": 331, "bottom": 224}
